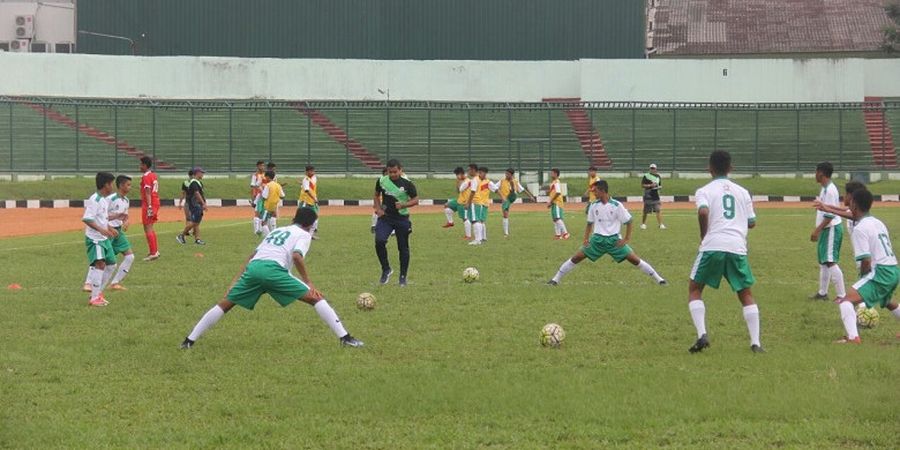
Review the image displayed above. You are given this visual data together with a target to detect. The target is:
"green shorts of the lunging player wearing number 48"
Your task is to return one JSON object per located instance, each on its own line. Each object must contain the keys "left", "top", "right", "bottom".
{"left": 225, "top": 260, "right": 309, "bottom": 309}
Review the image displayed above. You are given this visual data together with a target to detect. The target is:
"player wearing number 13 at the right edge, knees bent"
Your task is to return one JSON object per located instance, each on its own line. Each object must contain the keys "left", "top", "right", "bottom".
{"left": 835, "top": 189, "right": 900, "bottom": 344}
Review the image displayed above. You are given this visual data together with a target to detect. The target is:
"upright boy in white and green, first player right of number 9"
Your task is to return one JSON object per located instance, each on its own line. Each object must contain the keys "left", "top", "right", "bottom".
{"left": 809, "top": 162, "right": 847, "bottom": 300}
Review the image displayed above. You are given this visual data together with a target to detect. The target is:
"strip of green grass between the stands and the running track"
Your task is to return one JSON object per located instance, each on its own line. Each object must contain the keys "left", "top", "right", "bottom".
{"left": 0, "top": 175, "right": 900, "bottom": 200}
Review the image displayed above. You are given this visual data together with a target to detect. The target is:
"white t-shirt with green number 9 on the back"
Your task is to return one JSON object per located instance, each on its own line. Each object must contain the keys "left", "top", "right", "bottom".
{"left": 694, "top": 177, "right": 756, "bottom": 255}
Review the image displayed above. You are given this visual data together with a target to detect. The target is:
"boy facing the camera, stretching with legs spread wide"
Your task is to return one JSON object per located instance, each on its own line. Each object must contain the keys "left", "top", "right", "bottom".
{"left": 547, "top": 180, "right": 667, "bottom": 286}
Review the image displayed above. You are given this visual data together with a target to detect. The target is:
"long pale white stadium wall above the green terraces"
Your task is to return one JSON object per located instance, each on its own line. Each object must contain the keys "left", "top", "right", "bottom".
{"left": 0, "top": 53, "right": 900, "bottom": 102}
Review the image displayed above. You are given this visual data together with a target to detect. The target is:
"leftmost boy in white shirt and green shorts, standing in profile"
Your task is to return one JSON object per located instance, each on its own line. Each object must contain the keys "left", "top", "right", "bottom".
{"left": 81, "top": 172, "right": 118, "bottom": 306}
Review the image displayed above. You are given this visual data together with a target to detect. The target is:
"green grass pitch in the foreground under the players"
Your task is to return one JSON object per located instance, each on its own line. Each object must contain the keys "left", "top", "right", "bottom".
{"left": 0, "top": 209, "right": 900, "bottom": 449}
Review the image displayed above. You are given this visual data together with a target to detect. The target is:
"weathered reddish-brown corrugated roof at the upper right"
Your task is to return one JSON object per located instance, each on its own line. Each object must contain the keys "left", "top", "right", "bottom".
{"left": 651, "top": 0, "right": 891, "bottom": 55}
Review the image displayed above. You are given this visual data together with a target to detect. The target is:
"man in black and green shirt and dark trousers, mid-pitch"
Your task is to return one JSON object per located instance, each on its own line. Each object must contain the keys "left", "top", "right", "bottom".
{"left": 374, "top": 159, "right": 419, "bottom": 286}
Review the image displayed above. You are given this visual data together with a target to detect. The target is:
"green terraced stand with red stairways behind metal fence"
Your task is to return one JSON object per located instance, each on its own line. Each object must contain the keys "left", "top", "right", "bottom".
{"left": 0, "top": 97, "right": 900, "bottom": 173}
